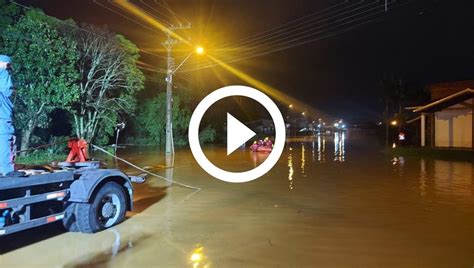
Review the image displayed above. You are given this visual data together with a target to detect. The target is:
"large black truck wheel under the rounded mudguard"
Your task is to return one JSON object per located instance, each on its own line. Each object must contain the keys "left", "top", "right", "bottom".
{"left": 75, "top": 182, "right": 127, "bottom": 233}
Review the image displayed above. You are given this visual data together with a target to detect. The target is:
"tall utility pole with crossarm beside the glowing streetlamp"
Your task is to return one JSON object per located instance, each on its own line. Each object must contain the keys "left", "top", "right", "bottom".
{"left": 162, "top": 24, "right": 191, "bottom": 155}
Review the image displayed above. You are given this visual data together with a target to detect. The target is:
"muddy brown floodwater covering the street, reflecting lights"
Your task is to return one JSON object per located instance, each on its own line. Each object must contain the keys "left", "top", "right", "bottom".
{"left": 0, "top": 135, "right": 474, "bottom": 267}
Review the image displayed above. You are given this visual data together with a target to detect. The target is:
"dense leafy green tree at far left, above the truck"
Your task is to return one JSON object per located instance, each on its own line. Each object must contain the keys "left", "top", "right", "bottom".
{"left": 2, "top": 10, "right": 79, "bottom": 150}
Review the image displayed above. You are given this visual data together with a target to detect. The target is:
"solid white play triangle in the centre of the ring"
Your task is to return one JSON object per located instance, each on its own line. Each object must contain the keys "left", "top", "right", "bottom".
{"left": 227, "top": 113, "right": 257, "bottom": 155}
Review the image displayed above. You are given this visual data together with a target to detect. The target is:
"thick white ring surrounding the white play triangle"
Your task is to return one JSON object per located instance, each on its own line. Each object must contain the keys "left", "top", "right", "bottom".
{"left": 188, "top": 86, "right": 286, "bottom": 183}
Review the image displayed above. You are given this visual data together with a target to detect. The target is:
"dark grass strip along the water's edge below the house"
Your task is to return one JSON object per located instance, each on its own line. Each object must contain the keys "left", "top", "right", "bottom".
{"left": 385, "top": 147, "right": 474, "bottom": 162}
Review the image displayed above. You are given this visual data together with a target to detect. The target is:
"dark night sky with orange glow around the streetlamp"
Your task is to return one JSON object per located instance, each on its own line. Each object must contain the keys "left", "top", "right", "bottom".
{"left": 14, "top": 0, "right": 474, "bottom": 121}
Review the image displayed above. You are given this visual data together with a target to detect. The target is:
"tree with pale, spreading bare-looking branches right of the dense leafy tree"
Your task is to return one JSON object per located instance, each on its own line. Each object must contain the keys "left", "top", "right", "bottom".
{"left": 71, "top": 24, "right": 144, "bottom": 142}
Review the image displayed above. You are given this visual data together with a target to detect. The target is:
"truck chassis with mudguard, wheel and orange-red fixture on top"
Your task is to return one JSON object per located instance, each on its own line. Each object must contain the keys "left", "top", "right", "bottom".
{"left": 0, "top": 139, "right": 145, "bottom": 236}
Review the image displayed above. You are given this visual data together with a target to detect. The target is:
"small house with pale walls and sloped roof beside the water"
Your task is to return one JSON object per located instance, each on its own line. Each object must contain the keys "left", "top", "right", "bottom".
{"left": 407, "top": 81, "right": 474, "bottom": 149}
